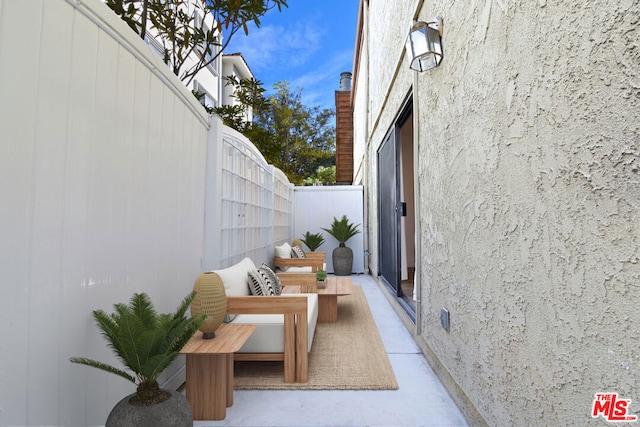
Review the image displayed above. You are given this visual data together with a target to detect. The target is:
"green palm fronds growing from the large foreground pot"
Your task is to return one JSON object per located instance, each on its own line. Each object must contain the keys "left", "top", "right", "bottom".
{"left": 70, "top": 292, "right": 206, "bottom": 406}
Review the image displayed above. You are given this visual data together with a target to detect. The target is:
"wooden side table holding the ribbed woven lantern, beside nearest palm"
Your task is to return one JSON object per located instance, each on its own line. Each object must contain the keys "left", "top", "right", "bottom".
{"left": 180, "top": 323, "right": 256, "bottom": 420}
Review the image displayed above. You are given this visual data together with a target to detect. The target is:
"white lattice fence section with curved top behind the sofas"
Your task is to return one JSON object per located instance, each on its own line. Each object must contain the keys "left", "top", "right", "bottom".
{"left": 204, "top": 117, "right": 293, "bottom": 270}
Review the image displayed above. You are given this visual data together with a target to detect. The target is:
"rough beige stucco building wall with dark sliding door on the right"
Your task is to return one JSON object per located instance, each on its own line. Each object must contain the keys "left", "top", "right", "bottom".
{"left": 352, "top": 0, "right": 640, "bottom": 426}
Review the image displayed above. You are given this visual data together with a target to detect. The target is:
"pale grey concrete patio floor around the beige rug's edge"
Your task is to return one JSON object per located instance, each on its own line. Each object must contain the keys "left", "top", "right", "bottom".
{"left": 193, "top": 275, "right": 468, "bottom": 427}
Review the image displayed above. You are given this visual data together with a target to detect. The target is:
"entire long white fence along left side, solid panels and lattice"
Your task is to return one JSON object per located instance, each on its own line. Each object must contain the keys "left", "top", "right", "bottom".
{"left": 0, "top": 0, "right": 293, "bottom": 426}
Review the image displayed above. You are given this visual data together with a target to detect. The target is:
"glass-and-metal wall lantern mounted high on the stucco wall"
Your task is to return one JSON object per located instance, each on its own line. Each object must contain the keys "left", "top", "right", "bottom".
{"left": 406, "top": 16, "right": 442, "bottom": 71}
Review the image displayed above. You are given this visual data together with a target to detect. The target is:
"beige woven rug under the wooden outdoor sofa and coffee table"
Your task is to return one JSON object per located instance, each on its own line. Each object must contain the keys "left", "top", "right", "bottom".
{"left": 235, "top": 286, "right": 398, "bottom": 390}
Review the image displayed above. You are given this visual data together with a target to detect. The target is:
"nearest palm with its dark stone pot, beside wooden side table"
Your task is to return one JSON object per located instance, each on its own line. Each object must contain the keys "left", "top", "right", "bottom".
{"left": 70, "top": 292, "right": 206, "bottom": 427}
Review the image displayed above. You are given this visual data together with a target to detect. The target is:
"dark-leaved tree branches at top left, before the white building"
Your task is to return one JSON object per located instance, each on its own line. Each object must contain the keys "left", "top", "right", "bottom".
{"left": 105, "top": 0, "right": 288, "bottom": 85}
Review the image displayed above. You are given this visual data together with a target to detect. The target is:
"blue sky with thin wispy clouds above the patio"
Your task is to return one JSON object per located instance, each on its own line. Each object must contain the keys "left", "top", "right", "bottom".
{"left": 225, "top": 0, "right": 358, "bottom": 113}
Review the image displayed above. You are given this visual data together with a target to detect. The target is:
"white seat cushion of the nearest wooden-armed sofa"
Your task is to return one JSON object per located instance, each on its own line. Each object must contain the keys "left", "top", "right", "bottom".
{"left": 233, "top": 294, "right": 318, "bottom": 353}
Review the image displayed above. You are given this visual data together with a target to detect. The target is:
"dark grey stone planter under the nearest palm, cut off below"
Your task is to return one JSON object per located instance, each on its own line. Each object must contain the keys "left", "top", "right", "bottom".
{"left": 105, "top": 390, "right": 193, "bottom": 427}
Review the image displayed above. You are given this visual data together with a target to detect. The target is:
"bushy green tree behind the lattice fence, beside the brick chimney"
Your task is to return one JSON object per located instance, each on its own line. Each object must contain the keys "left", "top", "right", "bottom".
{"left": 243, "top": 81, "right": 335, "bottom": 184}
